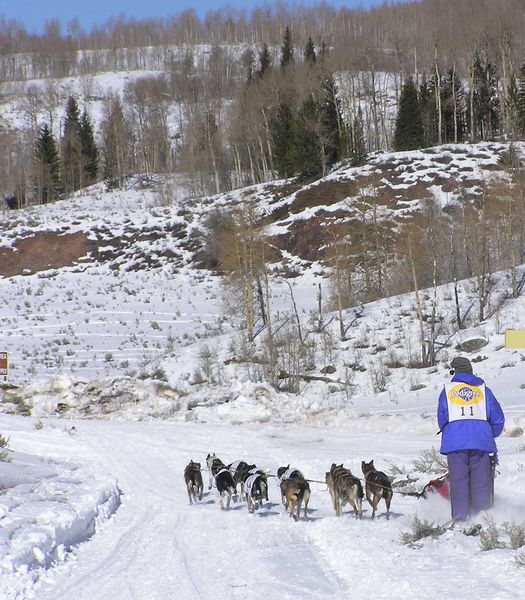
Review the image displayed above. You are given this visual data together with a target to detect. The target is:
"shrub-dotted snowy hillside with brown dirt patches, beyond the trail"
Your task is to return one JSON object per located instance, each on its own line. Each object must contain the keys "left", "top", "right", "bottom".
{"left": 0, "top": 144, "right": 523, "bottom": 419}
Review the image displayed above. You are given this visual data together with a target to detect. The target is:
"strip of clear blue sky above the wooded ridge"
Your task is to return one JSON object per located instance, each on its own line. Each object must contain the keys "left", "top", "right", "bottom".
{"left": 0, "top": 0, "right": 392, "bottom": 33}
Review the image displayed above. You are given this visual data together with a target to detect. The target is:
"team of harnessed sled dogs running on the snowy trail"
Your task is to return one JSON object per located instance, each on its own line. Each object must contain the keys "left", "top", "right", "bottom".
{"left": 184, "top": 453, "right": 392, "bottom": 521}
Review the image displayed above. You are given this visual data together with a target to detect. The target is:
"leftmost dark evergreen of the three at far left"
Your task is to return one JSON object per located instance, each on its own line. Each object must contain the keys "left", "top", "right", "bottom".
{"left": 34, "top": 123, "right": 61, "bottom": 203}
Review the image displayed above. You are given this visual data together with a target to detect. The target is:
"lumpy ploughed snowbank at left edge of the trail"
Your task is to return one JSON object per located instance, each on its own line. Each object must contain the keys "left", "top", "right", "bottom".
{"left": 0, "top": 417, "right": 121, "bottom": 580}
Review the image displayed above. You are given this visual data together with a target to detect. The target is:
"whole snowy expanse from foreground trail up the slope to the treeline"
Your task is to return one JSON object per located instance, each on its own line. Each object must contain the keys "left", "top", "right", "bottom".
{"left": 0, "top": 144, "right": 525, "bottom": 600}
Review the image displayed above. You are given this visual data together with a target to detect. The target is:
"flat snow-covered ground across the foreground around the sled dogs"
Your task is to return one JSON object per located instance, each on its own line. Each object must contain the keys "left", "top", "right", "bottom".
{"left": 0, "top": 408, "right": 525, "bottom": 600}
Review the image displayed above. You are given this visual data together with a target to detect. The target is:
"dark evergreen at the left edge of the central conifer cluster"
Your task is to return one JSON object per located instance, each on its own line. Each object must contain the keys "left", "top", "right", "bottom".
{"left": 271, "top": 99, "right": 298, "bottom": 177}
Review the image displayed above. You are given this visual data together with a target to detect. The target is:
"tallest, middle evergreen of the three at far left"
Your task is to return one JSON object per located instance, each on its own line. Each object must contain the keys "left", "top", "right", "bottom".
{"left": 60, "top": 96, "right": 83, "bottom": 193}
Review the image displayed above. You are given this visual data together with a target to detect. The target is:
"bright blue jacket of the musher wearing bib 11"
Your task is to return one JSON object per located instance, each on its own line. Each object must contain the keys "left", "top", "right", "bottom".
{"left": 437, "top": 373, "right": 505, "bottom": 454}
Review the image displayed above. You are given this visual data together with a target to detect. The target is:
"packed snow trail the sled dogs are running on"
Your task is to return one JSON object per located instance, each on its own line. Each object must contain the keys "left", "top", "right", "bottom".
{"left": 8, "top": 421, "right": 525, "bottom": 600}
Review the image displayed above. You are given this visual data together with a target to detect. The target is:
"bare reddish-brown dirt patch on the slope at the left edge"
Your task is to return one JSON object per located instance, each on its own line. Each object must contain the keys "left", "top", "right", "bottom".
{"left": 0, "top": 231, "right": 96, "bottom": 277}
